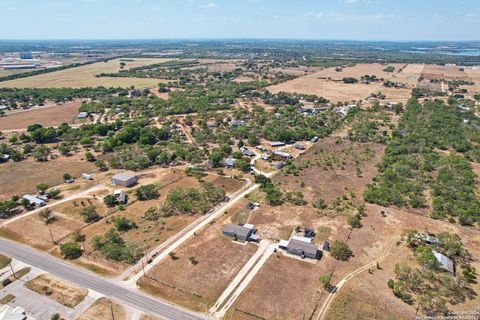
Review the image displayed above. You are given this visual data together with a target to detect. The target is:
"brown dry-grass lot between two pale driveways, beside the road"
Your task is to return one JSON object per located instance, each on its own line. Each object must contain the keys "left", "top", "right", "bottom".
{"left": 140, "top": 200, "right": 257, "bottom": 311}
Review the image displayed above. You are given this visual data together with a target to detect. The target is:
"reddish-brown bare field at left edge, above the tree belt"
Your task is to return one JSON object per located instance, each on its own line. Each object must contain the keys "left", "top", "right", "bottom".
{"left": 0, "top": 101, "right": 81, "bottom": 130}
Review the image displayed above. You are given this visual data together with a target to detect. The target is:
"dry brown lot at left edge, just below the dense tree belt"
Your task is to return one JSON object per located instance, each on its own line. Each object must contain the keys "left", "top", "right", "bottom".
{"left": 0, "top": 157, "right": 96, "bottom": 200}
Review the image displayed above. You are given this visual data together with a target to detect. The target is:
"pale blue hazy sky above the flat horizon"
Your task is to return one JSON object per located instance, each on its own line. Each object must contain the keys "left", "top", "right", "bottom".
{"left": 0, "top": 0, "right": 480, "bottom": 41}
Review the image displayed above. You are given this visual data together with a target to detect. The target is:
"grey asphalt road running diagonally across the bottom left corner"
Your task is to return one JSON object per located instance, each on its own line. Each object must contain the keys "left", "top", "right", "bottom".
{"left": 0, "top": 238, "right": 207, "bottom": 320}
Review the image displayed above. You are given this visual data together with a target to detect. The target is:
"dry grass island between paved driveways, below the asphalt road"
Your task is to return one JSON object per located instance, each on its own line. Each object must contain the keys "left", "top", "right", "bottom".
{"left": 25, "top": 274, "right": 88, "bottom": 308}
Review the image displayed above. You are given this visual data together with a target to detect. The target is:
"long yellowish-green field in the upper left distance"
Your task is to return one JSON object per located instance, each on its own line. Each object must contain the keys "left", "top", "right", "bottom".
{"left": 0, "top": 58, "right": 172, "bottom": 88}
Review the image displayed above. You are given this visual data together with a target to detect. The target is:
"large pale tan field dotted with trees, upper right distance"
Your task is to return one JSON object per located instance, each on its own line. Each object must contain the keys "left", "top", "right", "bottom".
{"left": 268, "top": 64, "right": 423, "bottom": 102}
